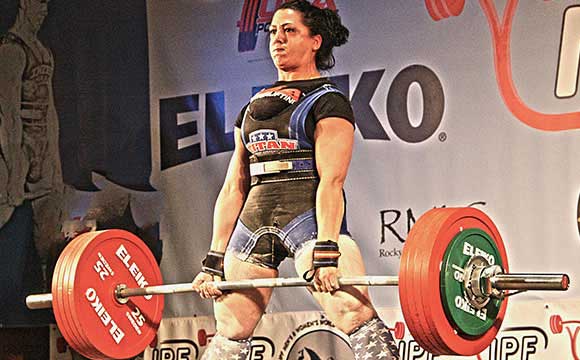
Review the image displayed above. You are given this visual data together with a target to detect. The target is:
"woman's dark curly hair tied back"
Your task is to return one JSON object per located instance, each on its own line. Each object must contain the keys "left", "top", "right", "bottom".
{"left": 276, "top": 0, "right": 349, "bottom": 70}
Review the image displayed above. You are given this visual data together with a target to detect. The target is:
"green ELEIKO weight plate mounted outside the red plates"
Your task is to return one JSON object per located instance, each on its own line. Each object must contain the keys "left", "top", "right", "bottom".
{"left": 441, "top": 229, "right": 503, "bottom": 336}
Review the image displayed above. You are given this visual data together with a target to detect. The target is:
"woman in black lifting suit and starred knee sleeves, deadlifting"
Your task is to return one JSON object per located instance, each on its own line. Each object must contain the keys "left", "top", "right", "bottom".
{"left": 193, "top": 0, "right": 398, "bottom": 360}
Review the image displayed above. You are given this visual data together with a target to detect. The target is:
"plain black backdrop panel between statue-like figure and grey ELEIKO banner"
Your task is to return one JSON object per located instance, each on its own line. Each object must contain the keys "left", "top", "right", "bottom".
{"left": 44, "top": 0, "right": 153, "bottom": 191}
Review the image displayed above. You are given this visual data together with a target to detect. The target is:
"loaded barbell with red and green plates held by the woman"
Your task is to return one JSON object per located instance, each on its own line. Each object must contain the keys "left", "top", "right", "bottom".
{"left": 26, "top": 208, "right": 569, "bottom": 359}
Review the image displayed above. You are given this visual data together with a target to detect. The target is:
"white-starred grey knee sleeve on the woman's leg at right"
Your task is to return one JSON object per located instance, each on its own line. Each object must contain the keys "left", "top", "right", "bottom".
{"left": 349, "top": 317, "right": 399, "bottom": 360}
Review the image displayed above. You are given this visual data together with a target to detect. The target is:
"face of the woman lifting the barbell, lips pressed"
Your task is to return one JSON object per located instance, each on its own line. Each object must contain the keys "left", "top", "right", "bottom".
{"left": 270, "top": 9, "right": 322, "bottom": 72}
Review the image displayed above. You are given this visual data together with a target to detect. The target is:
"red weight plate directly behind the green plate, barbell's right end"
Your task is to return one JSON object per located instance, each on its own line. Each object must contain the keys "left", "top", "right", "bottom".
{"left": 412, "top": 208, "right": 509, "bottom": 355}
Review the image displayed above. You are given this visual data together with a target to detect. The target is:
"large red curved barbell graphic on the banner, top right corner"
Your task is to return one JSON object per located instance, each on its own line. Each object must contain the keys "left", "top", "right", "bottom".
{"left": 425, "top": 0, "right": 580, "bottom": 131}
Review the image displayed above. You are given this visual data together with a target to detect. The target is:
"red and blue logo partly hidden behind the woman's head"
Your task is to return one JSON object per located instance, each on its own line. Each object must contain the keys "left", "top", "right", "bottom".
{"left": 237, "top": 0, "right": 336, "bottom": 52}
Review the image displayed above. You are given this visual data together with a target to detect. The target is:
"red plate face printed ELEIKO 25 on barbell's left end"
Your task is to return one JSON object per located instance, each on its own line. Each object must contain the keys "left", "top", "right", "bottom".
{"left": 71, "top": 230, "right": 164, "bottom": 359}
